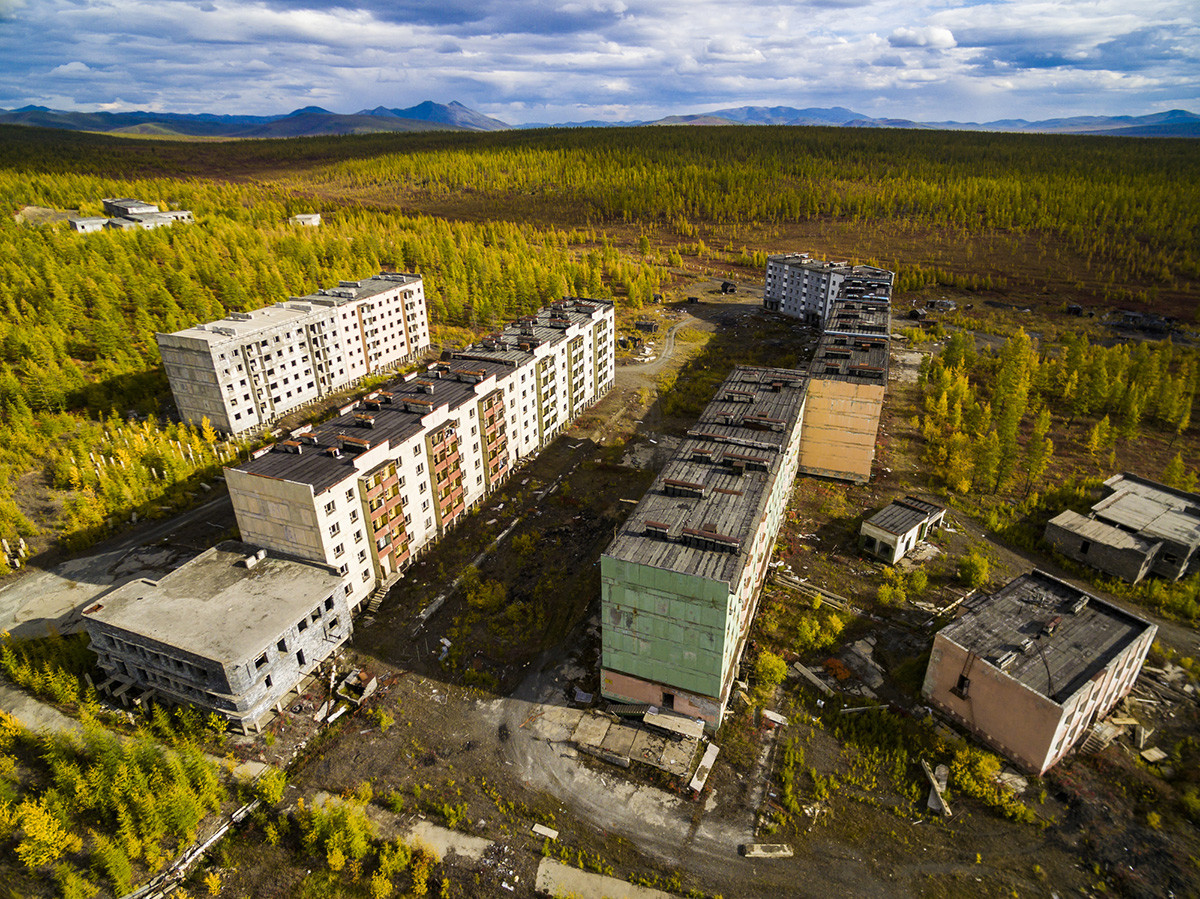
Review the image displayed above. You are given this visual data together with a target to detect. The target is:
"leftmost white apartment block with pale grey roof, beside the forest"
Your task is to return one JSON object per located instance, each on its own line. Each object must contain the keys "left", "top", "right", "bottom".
{"left": 157, "top": 271, "right": 430, "bottom": 433}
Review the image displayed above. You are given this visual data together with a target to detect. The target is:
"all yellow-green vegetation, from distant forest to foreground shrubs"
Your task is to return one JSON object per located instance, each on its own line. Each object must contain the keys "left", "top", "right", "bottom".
{"left": 0, "top": 127, "right": 1200, "bottom": 897}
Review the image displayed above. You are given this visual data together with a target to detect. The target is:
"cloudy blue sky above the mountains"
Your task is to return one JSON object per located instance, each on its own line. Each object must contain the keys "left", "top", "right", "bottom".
{"left": 0, "top": 0, "right": 1200, "bottom": 124}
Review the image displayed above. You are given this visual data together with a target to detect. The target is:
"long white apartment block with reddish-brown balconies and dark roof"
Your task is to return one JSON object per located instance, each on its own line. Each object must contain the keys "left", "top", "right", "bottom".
{"left": 226, "top": 300, "right": 616, "bottom": 609}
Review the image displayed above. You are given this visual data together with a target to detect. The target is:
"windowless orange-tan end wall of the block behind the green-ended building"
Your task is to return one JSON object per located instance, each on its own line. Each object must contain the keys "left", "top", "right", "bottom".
{"left": 799, "top": 378, "right": 883, "bottom": 483}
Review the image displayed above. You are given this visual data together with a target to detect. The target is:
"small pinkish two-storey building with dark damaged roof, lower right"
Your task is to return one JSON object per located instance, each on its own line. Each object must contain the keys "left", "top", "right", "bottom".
{"left": 923, "top": 571, "right": 1158, "bottom": 774}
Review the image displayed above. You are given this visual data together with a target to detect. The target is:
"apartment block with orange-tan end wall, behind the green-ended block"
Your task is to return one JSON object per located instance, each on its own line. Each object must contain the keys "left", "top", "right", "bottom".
{"left": 800, "top": 299, "right": 892, "bottom": 484}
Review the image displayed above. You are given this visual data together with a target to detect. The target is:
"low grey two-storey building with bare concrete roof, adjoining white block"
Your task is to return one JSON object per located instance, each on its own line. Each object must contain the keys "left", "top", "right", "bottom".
{"left": 83, "top": 540, "right": 353, "bottom": 730}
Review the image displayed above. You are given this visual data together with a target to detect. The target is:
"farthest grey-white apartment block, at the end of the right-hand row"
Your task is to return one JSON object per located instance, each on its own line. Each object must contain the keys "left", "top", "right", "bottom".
{"left": 763, "top": 253, "right": 895, "bottom": 324}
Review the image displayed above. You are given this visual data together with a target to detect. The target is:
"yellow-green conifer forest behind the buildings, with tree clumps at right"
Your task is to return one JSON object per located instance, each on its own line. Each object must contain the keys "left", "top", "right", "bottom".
{"left": 0, "top": 127, "right": 1200, "bottom": 556}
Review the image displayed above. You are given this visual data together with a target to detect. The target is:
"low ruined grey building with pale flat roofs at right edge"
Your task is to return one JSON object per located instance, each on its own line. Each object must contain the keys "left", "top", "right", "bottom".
{"left": 1045, "top": 472, "right": 1200, "bottom": 583}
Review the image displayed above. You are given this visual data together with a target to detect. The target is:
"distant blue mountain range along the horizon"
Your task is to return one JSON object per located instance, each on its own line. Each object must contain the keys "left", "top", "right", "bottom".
{"left": 0, "top": 100, "right": 1200, "bottom": 138}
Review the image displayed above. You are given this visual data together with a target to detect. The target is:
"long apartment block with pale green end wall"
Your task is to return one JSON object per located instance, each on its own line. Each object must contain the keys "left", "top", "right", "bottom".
{"left": 600, "top": 366, "right": 805, "bottom": 729}
